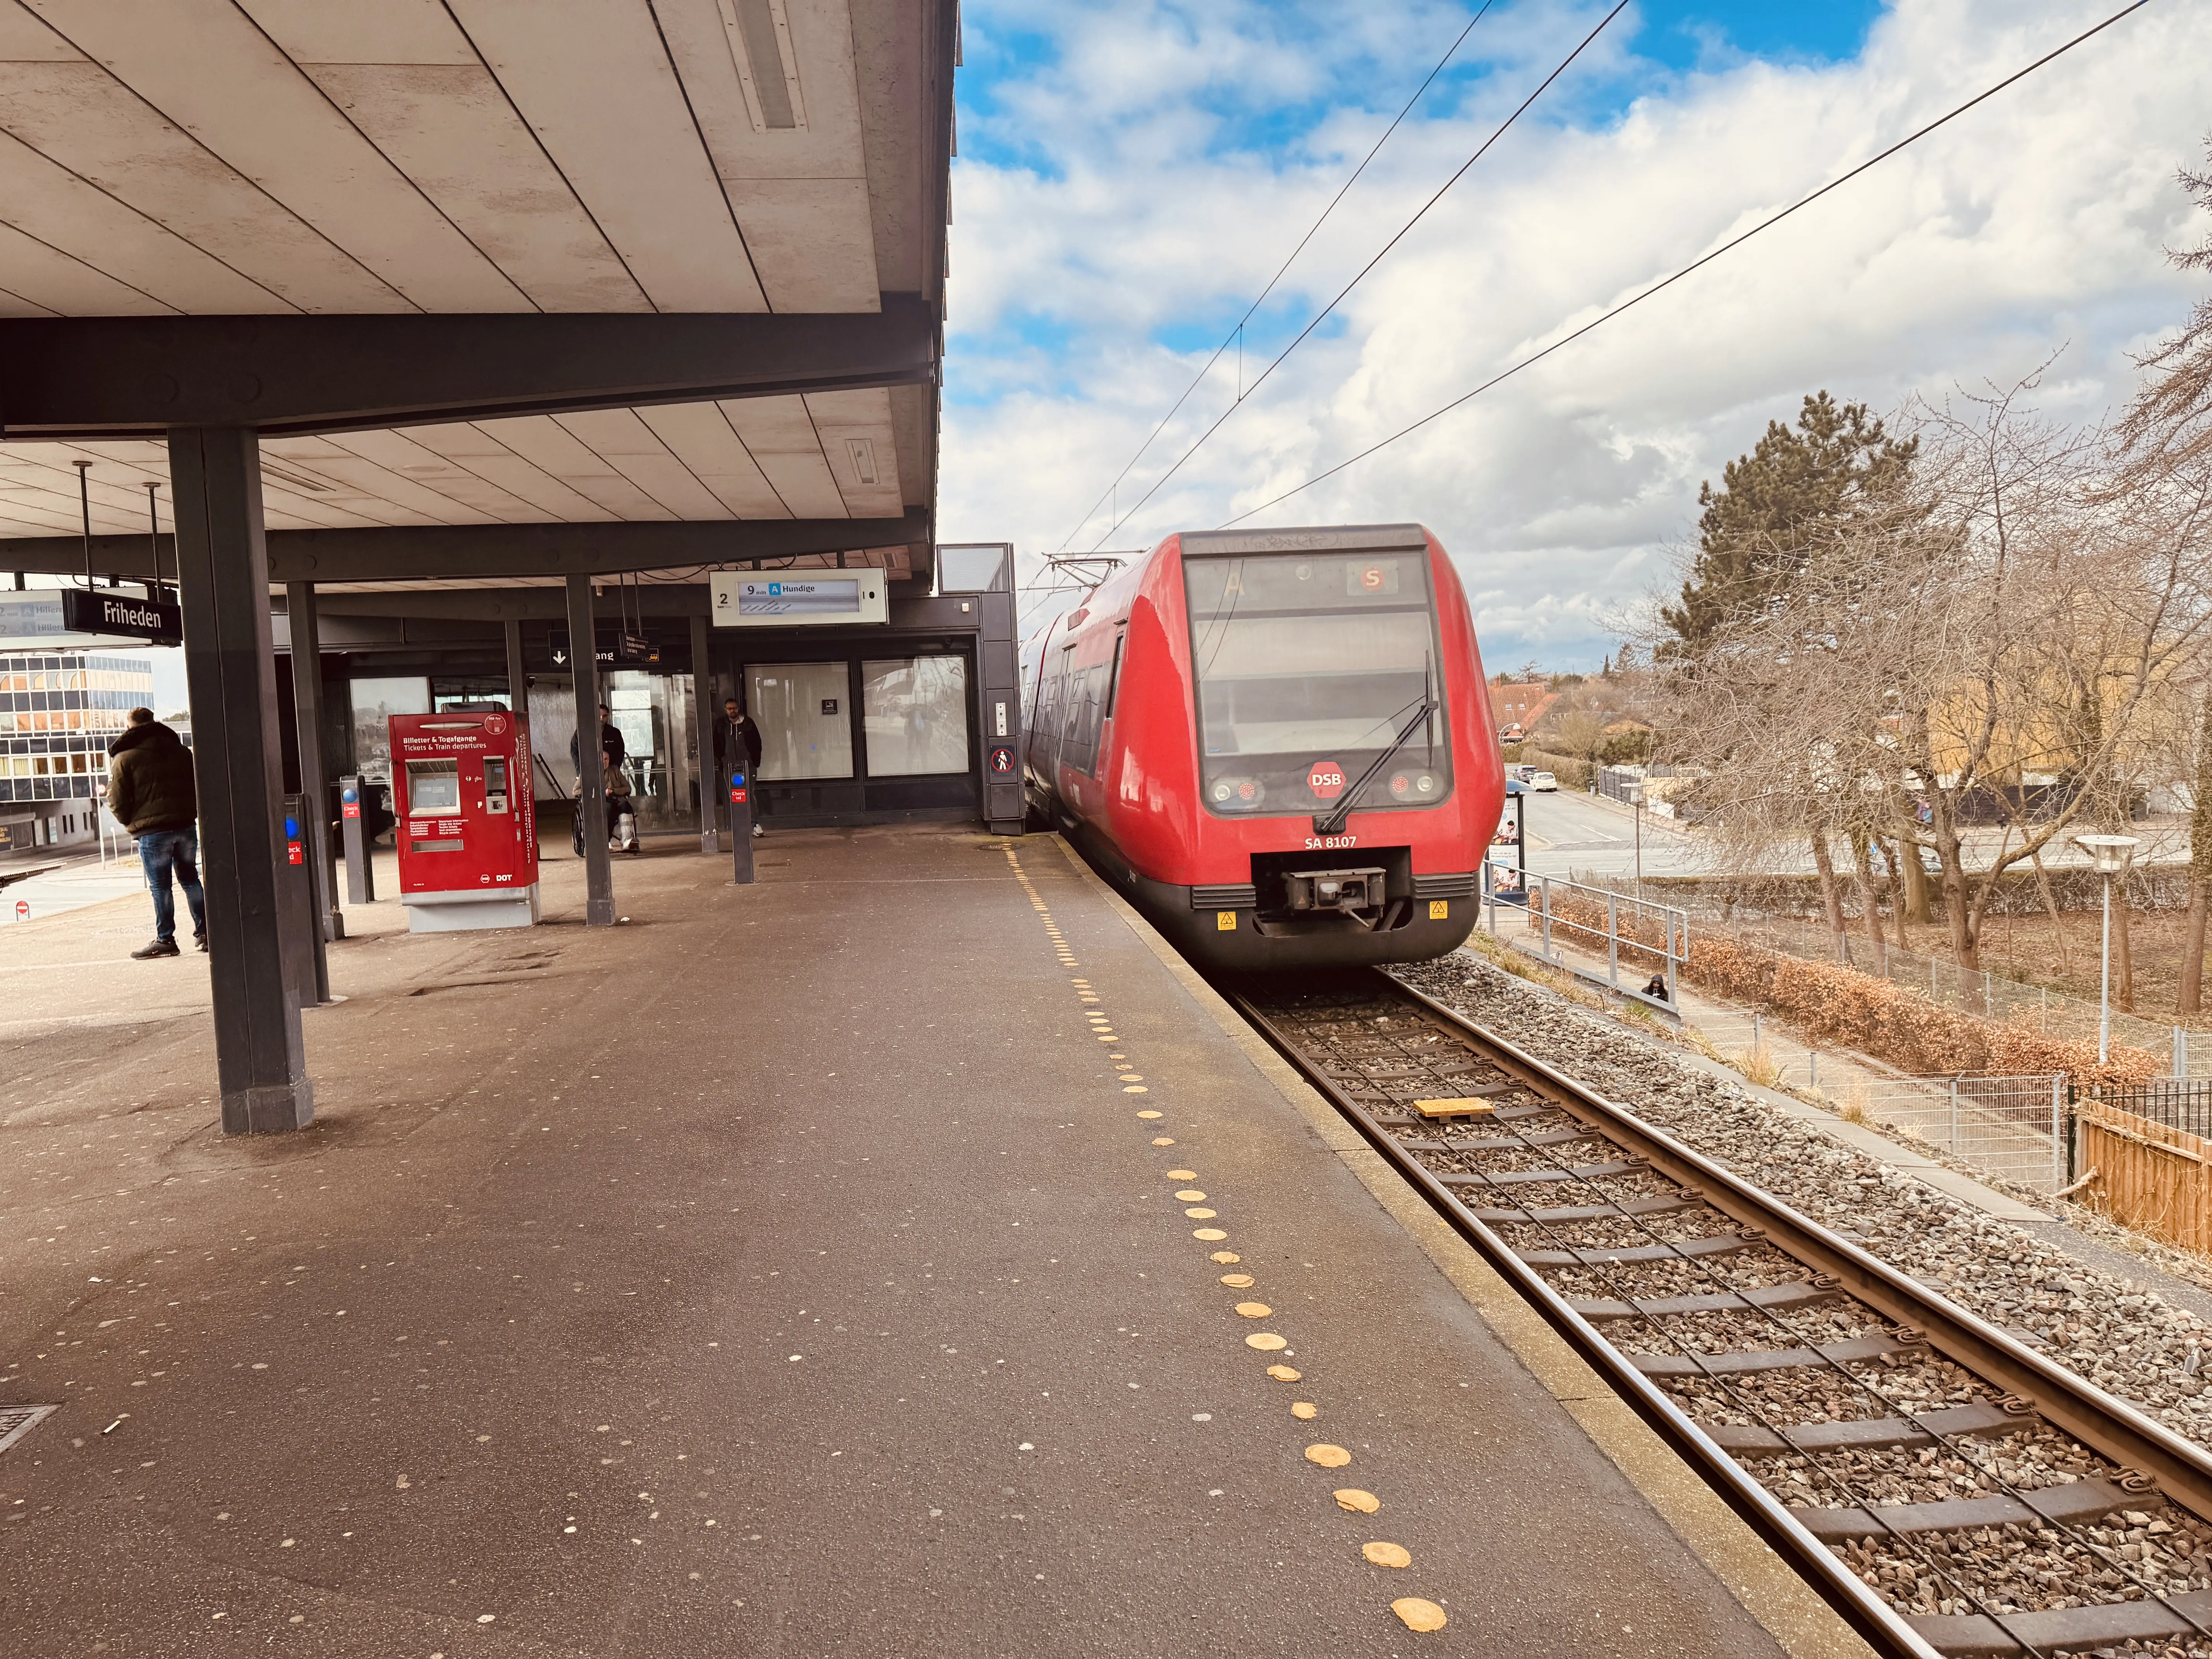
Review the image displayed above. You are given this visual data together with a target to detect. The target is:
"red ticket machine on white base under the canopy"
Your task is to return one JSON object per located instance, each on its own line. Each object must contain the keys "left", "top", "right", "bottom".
{"left": 392, "top": 710, "right": 538, "bottom": 933}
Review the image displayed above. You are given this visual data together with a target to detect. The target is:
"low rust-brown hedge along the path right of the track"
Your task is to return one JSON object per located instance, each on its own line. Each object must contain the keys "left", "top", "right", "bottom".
{"left": 1553, "top": 896, "right": 2159, "bottom": 1088}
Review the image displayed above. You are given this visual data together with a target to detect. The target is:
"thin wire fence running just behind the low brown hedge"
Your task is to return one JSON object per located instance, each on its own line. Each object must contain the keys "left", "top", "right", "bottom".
{"left": 1575, "top": 872, "right": 2212, "bottom": 1077}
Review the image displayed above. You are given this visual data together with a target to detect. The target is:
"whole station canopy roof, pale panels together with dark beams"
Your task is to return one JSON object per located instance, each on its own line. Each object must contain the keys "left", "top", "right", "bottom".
{"left": 0, "top": 0, "right": 953, "bottom": 588}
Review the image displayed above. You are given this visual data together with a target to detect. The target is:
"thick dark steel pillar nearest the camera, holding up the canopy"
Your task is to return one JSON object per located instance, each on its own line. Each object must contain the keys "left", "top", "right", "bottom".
{"left": 168, "top": 427, "right": 314, "bottom": 1135}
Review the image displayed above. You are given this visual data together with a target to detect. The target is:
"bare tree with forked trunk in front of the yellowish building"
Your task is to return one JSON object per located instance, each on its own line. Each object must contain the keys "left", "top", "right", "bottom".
{"left": 1885, "top": 378, "right": 2212, "bottom": 971}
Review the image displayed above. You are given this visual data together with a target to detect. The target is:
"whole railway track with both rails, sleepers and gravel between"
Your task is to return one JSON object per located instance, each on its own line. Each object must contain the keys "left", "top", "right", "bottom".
{"left": 1223, "top": 971, "right": 2212, "bottom": 1657}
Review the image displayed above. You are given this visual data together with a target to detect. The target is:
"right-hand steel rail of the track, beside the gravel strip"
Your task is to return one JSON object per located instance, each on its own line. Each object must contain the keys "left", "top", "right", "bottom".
{"left": 1389, "top": 980, "right": 2212, "bottom": 1520}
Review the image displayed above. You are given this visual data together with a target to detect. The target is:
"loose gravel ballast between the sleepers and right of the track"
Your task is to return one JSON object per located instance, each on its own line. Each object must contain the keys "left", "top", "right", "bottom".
{"left": 1378, "top": 951, "right": 2212, "bottom": 1659}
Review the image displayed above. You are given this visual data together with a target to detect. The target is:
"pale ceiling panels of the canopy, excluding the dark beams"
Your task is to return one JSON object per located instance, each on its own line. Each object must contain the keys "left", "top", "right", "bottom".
{"left": 0, "top": 0, "right": 951, "bottom": 580}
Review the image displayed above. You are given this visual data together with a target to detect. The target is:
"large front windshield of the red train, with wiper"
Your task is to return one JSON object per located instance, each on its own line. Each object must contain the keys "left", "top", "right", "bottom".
{"left": 1183, "top": 549, "right": 1451, "bottom": 816}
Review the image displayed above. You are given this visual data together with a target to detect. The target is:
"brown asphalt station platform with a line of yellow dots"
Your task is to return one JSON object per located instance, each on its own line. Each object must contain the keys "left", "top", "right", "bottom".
{"left": 0, "top": 827, "right": 1831, "bottom": 1659}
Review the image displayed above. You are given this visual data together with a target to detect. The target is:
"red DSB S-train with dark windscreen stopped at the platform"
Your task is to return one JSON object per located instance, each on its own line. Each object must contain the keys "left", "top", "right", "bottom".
{"left": 1022, "top": 524, "right": 1504, "bottom": 969}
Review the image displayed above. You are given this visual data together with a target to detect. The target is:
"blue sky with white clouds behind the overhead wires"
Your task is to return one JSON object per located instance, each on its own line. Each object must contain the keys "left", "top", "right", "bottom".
{"left": 940, "top": 0, "right": 2212, "bottom": 672}
